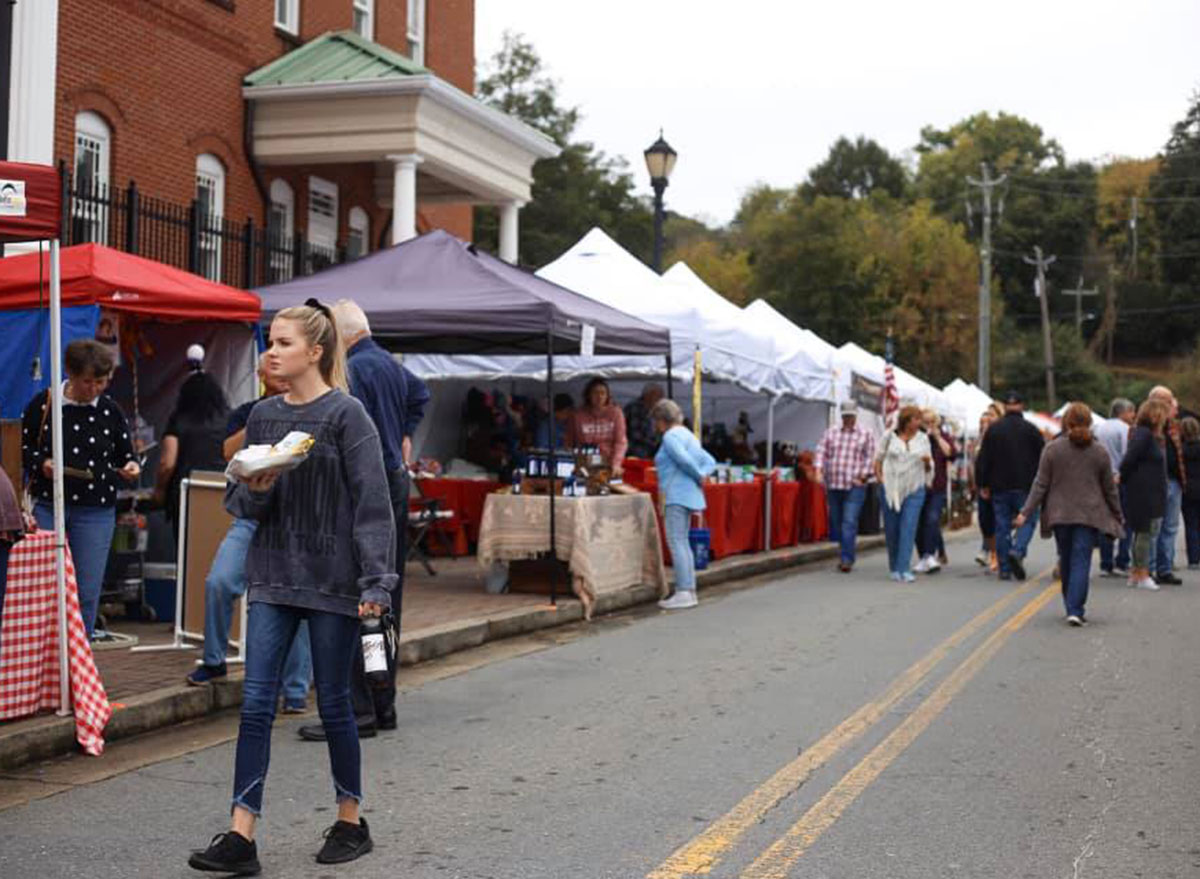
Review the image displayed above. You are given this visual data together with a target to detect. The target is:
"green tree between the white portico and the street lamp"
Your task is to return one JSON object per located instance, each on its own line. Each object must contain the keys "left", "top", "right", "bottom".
{"left": 474, "top": 32, "right": 654, "bottom": 267}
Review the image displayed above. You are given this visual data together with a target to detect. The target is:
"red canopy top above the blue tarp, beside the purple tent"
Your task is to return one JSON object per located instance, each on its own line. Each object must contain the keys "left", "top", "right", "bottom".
{"left": 0, "top": 244, "right": 262, "bottom": 323}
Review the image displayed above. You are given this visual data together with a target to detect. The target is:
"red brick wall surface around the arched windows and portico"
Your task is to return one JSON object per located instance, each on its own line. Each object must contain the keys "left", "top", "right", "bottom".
{"left": 55, "top": 0, "right": 474, "bottom": 247}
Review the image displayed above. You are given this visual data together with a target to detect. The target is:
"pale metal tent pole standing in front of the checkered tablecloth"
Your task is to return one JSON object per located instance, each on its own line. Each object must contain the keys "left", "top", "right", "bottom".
{"left": 50, "top": 238, "right": 72, "bottom": 717}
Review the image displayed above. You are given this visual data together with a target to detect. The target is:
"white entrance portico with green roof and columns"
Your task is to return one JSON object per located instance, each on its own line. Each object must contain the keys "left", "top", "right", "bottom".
{"left": 242, "top": 31, "right": 559, "bottom": 262}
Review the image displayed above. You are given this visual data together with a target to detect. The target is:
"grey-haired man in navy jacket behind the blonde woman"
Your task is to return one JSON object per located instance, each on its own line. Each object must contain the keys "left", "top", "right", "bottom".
{"left": 300, "top": 299, "right": 430, "bottom": 741}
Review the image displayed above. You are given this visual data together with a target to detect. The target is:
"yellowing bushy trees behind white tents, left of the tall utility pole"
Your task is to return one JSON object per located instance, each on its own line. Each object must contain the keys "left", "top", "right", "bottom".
{"left": 738, "top": 189, "right": 977, "bottom": 383}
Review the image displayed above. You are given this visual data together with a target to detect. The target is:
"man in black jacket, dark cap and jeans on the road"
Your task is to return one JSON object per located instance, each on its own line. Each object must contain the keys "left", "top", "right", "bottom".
{"left": 976, "top": 390, "right": 1045, "bottom": 580}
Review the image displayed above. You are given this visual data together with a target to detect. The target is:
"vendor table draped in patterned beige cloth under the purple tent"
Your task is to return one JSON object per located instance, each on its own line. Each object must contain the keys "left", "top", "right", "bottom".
{"left": 479, "top": 494, "right": 667, "bottom": 617}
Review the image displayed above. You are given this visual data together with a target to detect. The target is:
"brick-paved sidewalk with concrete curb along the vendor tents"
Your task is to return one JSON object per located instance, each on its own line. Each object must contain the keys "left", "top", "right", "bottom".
{"left": 0, "top": 536, "right": 883, "bottom": 770}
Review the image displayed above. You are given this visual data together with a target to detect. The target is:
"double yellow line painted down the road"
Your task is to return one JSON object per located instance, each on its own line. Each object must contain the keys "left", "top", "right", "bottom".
{"left": 647, "top": 568, "right": 1060, "bottom": 879}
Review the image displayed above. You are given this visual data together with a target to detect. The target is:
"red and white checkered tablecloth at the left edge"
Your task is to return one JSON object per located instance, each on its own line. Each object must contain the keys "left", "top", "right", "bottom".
{"left": 0, "top": 531, "right": 113, "bottom": 757}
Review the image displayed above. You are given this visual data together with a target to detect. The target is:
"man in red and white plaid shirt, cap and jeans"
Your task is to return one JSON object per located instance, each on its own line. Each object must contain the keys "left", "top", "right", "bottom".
{"left": 816, "top": 402, "right": 875, "bottom": 574}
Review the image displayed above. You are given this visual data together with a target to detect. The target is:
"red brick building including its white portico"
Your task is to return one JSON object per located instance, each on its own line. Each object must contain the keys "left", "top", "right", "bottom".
{"left": 10, "top": 0, "right": 557, "bottom": 281}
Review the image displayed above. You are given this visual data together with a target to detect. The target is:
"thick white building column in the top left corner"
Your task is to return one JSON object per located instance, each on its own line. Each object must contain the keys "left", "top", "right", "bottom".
{"left": 6, "top": 0, "right": 59, "bottom": 165}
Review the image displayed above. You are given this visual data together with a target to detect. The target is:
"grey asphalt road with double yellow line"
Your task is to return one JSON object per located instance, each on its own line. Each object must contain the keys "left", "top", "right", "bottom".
{"left": 0, "top": 533, "right": 1200, "bottom": 879}
